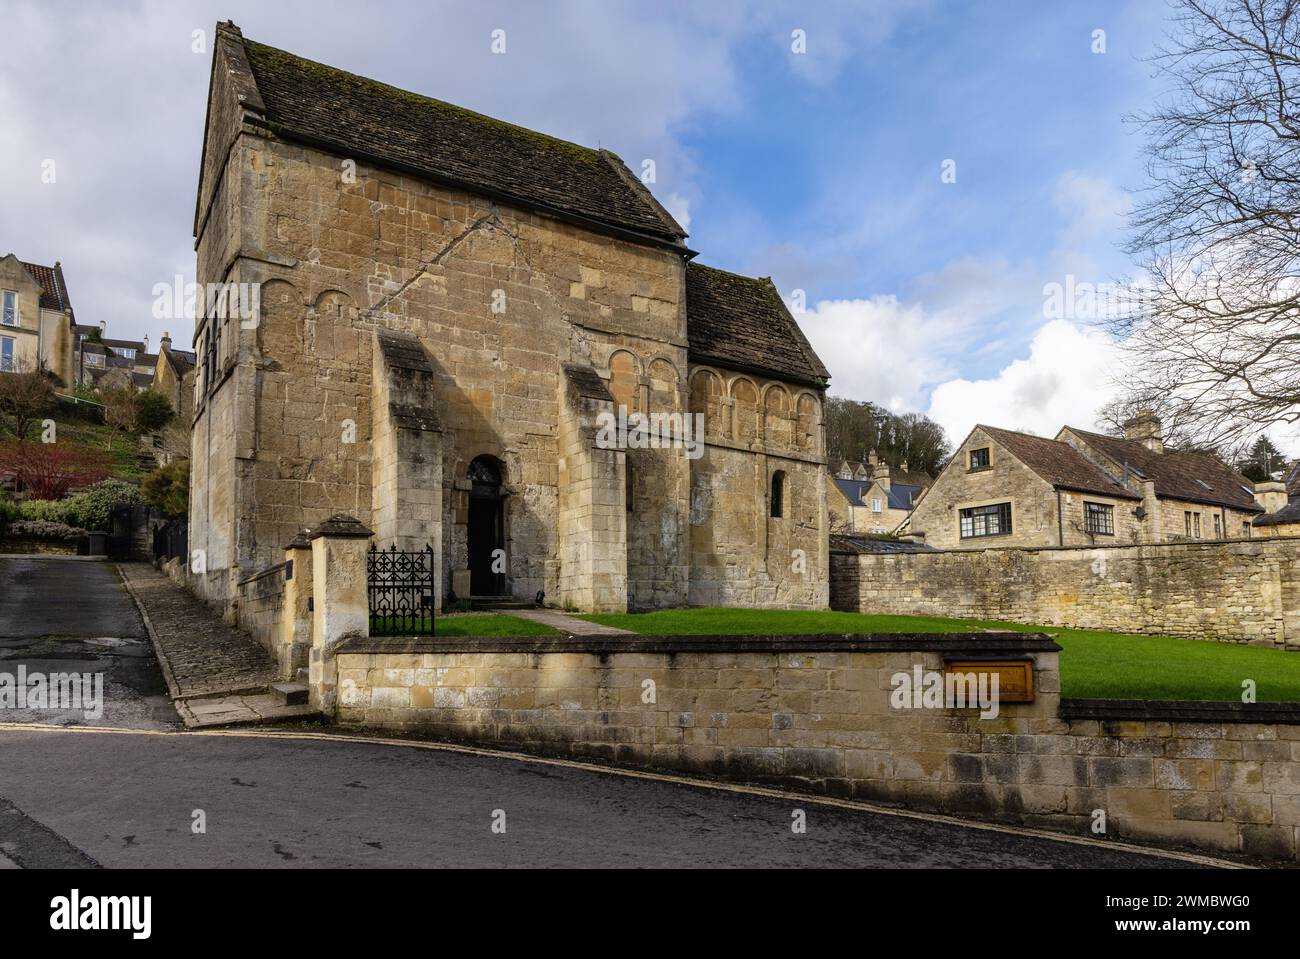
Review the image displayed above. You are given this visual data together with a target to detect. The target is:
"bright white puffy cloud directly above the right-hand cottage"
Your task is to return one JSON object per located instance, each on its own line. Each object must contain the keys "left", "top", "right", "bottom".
{"left": 927, "top": 320, "right": 1118, "bottom": 443}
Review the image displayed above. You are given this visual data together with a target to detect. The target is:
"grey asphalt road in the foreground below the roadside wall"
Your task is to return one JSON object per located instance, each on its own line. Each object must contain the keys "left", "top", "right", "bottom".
{"left": 0, "top": 726, "right": 1206, "bottom": 868}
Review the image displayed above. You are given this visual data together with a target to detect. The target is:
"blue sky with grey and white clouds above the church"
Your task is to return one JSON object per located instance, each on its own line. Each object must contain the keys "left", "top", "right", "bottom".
{"left": 0, "top": 0, "right": 1300, "bottom": 454}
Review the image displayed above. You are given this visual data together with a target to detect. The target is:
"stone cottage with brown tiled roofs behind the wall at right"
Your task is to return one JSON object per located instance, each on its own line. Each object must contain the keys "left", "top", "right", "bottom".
{"left": 909, "top": 413, "right": 1264, "bottom": 550}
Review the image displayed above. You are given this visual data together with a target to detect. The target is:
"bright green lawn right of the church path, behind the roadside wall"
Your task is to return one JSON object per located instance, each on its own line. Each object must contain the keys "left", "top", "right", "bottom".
{"left": 581, "top": 609, "right": 1300, "bottom": 702}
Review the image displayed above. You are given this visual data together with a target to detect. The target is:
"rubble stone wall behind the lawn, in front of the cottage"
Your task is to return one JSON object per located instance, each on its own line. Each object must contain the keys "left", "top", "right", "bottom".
{"left": 831, "top": 538, "right": 1300, "bottom": 650}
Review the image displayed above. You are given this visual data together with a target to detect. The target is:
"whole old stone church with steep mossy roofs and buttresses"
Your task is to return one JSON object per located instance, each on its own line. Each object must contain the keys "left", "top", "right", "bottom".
{"left": 190, "top": 23, "right": 828, "bottom": 611}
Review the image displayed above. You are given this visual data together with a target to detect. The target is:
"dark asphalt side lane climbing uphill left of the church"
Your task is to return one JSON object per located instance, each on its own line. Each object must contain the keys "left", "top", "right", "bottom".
{"left": 0, "top": 556, "right": 181, "bottom": 722}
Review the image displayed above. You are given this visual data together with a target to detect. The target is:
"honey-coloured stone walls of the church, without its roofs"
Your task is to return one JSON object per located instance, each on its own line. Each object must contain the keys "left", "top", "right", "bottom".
{"left": 191, "top": 39, "right": 827, "bottom": 608}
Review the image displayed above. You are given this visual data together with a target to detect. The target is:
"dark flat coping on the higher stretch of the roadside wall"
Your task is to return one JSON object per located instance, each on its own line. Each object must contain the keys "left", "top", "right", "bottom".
{"left": 337, "top": 632, "right": 1061, "bottom": 656}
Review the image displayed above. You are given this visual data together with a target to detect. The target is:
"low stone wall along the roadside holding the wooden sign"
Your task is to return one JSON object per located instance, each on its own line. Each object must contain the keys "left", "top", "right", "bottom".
{"left": 322, "top": 633, "right": 1300, "bottom": 859}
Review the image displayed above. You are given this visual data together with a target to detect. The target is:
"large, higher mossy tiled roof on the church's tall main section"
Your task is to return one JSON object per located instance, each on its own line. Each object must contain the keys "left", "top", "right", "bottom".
{"left": 242, "top": 39, "right": 686, "bottom": 244}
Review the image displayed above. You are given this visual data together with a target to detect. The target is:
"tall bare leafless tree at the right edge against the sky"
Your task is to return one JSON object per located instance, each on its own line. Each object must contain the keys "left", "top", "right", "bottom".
{"left": 1113, "top": 0, "right": 1300, "bottom": 451}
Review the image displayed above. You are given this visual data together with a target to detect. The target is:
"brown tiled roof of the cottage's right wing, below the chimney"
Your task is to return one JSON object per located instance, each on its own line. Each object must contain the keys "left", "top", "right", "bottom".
{"left": 1066, "top": 426, "right": 1260, "bottom": 512}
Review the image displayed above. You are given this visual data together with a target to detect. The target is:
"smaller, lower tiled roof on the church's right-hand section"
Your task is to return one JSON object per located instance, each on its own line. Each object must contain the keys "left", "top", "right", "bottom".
{"left": 686, "top": 262, "right": 831, "bottom": 387}
